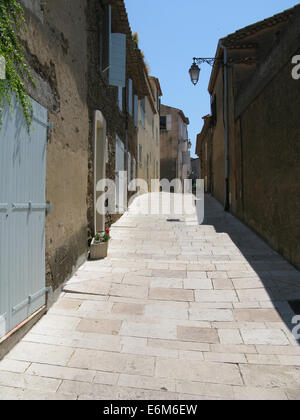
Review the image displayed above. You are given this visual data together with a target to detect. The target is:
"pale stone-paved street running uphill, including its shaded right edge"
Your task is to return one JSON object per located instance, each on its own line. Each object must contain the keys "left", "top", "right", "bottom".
{"left": 0, "top": 196, "right": 300, "bottom": 400}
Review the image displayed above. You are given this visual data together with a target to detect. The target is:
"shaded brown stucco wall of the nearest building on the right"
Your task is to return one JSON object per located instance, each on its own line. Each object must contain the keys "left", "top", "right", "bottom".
{"left": 239, "top": 50, "right": 300, "bottom": 267}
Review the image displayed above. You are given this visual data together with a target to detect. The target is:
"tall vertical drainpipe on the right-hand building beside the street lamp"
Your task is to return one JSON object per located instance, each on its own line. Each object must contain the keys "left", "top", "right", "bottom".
{"left": 220, "top": 41, "right": 230, "bottom": 211}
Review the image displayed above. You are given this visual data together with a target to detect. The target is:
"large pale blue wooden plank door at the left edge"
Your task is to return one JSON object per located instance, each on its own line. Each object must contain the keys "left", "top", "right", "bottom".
{"left": 0, "top": 100, "right": 47, "bottom": 338}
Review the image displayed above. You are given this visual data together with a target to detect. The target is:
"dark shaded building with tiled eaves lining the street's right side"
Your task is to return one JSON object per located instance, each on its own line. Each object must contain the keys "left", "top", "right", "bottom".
{"left": 197, "top": 5, "right": 300, "bottom": 268}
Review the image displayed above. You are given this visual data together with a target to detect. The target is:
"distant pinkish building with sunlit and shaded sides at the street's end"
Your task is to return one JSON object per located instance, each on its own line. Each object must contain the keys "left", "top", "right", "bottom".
{"left": 160, "top": 105, "right": 191, "bottom": 182}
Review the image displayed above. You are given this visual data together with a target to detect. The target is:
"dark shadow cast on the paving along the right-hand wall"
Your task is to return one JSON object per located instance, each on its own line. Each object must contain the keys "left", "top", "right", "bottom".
{"left": 203, "top": 195, "right": 300, "bottom": 344}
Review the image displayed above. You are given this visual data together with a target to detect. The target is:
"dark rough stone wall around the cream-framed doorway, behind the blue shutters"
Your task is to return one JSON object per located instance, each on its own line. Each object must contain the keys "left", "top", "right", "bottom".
{"left": 86, "top": 0, "right": 137, "bottom": 230}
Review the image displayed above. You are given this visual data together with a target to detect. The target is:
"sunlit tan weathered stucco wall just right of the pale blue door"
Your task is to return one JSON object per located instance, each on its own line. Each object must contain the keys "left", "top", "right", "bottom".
{"left": 22, "top": 0, "right": 89, "bottom": 288}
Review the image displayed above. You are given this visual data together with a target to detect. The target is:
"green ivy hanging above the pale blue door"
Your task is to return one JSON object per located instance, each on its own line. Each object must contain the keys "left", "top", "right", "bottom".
{"left": 0, "top": 0, "right": 34, "bottom": 131}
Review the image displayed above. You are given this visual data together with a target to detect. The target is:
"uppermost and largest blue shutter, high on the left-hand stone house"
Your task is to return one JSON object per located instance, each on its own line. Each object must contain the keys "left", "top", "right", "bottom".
{"left": 109, "top": 34, "right": 126, "bottom": 87}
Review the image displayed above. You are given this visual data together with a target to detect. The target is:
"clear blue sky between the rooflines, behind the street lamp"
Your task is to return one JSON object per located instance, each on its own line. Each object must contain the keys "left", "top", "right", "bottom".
{"left": 125, "top": 0, "right": 299, "bottom": 156}
